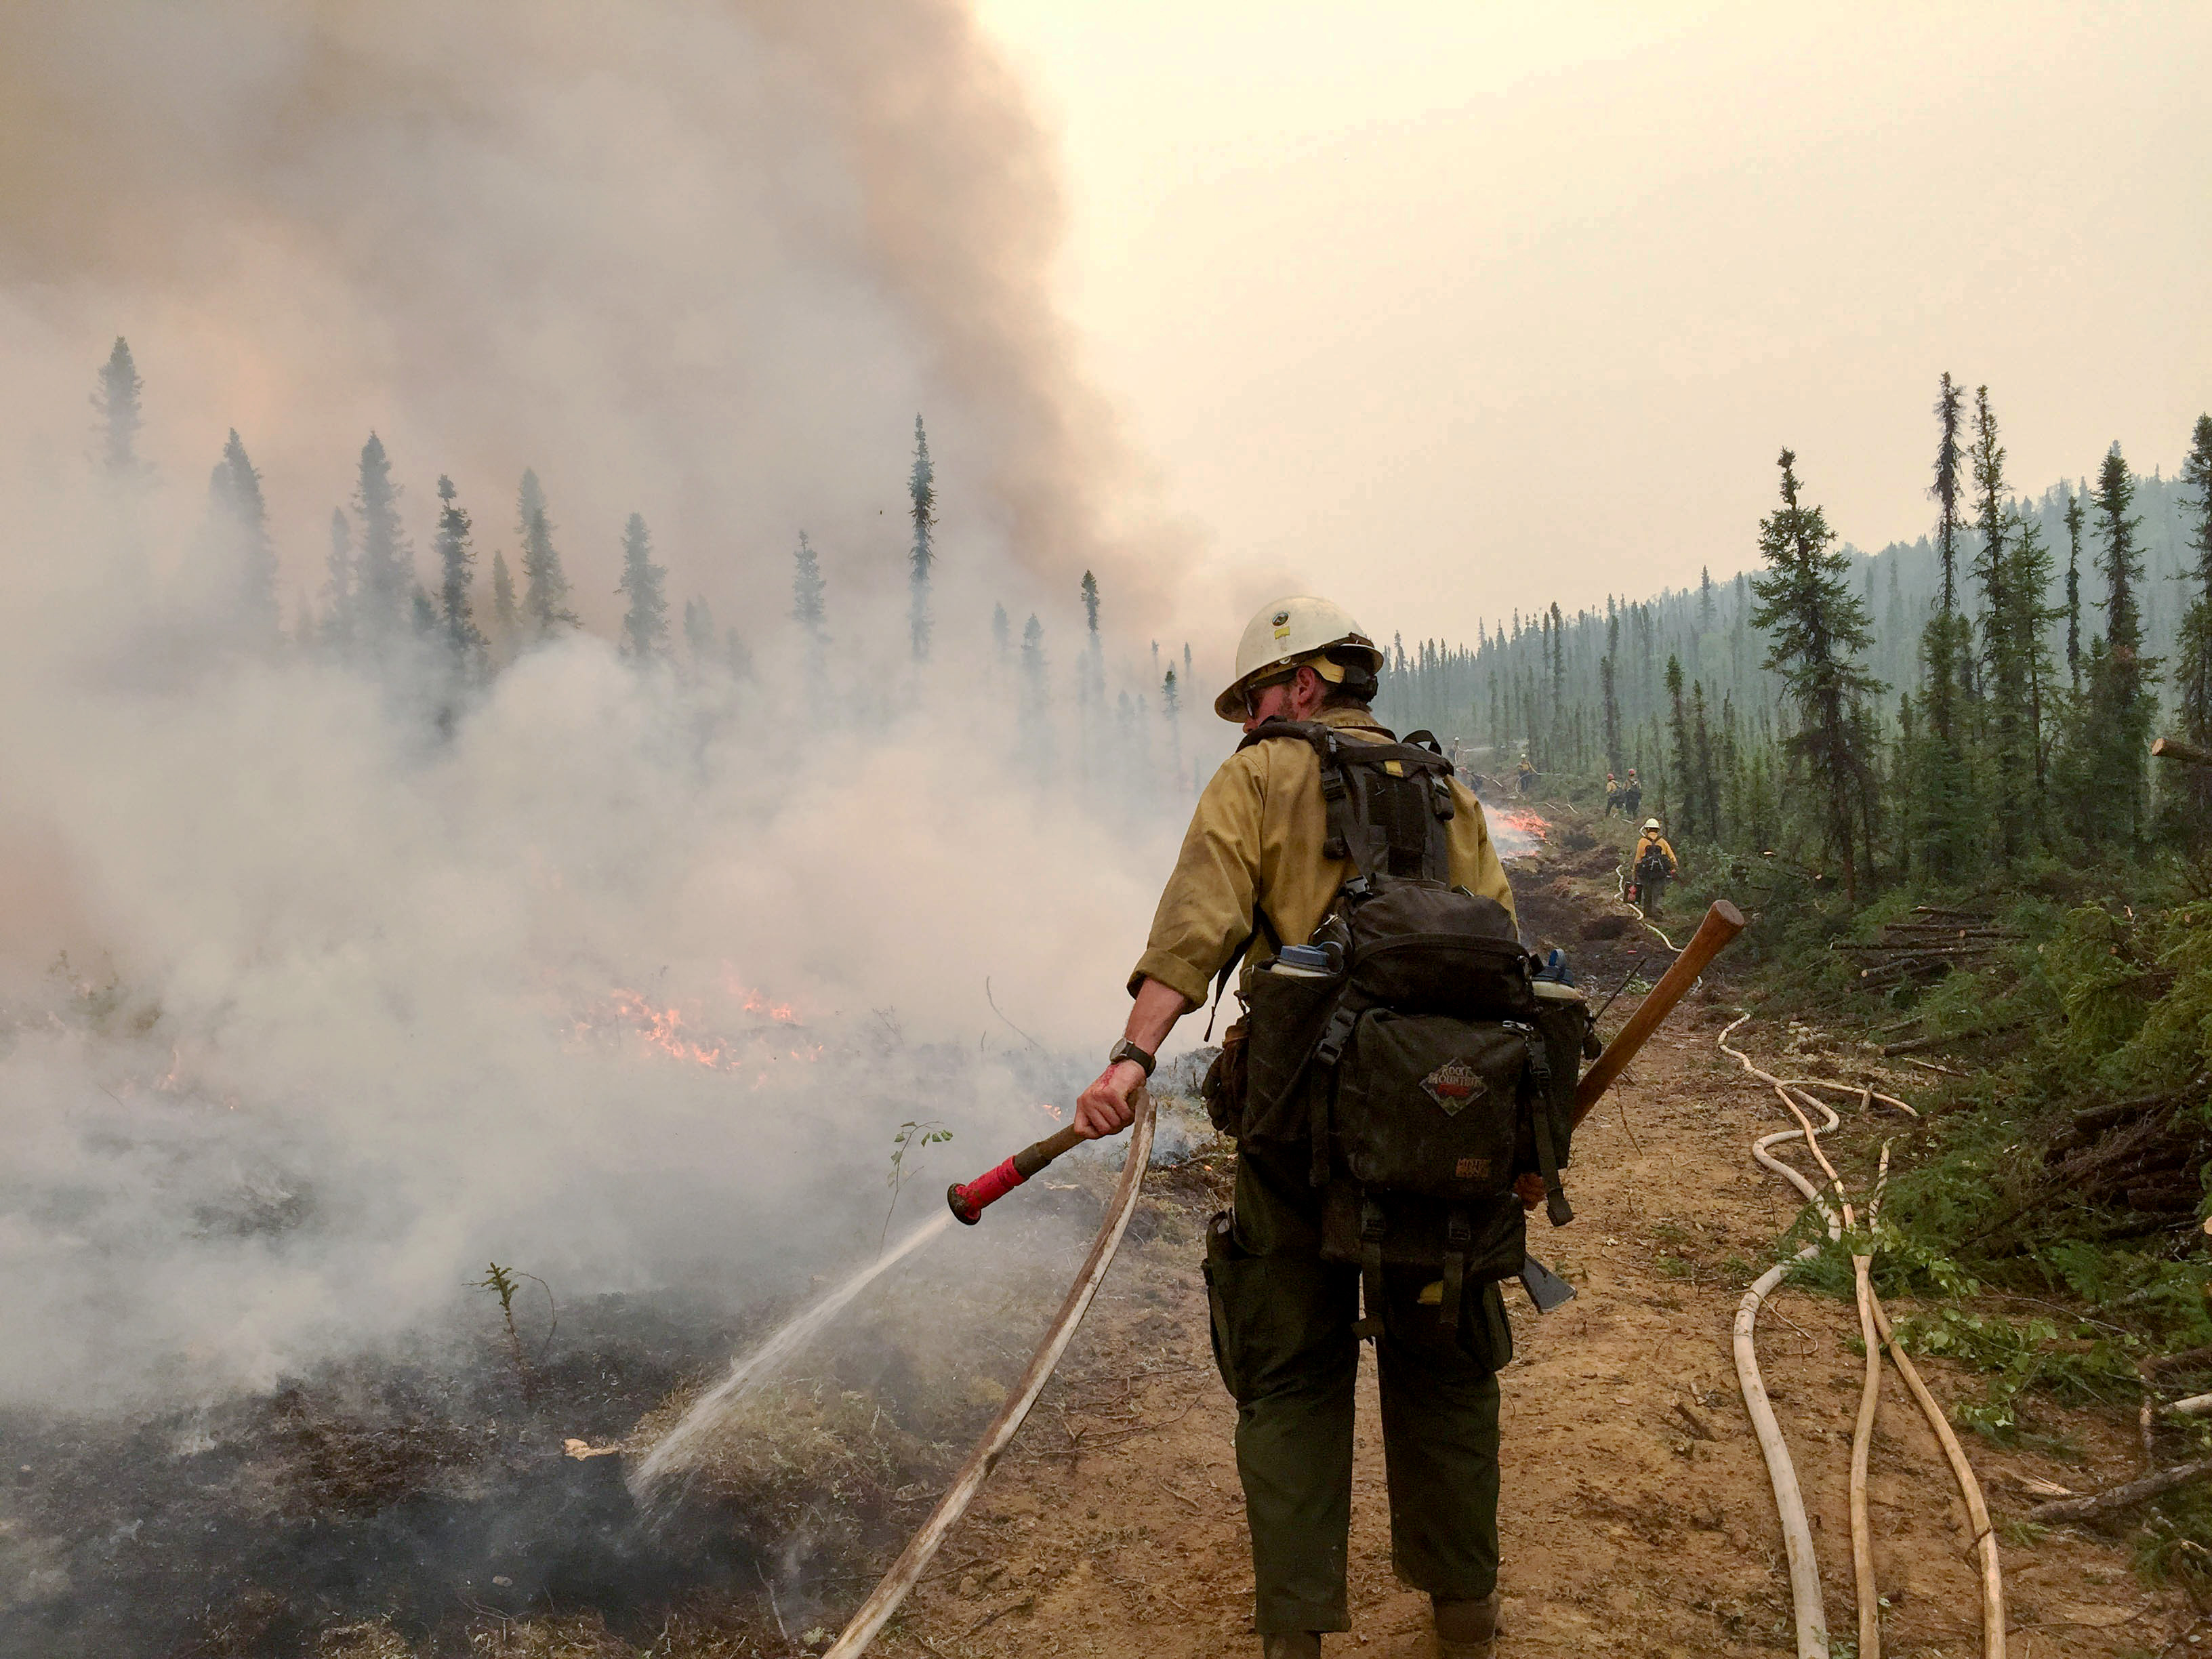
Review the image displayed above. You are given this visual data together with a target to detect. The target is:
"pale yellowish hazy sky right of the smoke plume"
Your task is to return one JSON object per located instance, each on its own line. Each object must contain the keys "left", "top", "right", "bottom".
{"left": 980, "top": 0, "right": 2212, "bottom": 650}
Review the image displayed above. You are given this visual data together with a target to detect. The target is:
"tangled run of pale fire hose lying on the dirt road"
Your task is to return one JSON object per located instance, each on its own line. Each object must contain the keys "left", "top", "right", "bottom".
{"left": 1719, "top": 1013, "right": 2004, "bottom": 1659}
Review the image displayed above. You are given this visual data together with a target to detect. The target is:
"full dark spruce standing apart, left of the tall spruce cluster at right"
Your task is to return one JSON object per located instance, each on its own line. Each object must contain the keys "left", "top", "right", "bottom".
{"left": 1752, "top": 449, "right": 1887, "bottom": 905}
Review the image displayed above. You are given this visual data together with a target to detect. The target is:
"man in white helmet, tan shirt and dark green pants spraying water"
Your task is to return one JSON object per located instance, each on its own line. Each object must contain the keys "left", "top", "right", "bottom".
{"left": 1075, "top": 597, "right": 1544, "bottom": 1659}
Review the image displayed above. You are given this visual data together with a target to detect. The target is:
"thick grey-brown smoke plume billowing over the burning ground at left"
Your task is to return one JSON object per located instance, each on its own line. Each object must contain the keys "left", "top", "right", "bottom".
{"left": 0, "top": 0, "right": 1201, "bottom": 1407}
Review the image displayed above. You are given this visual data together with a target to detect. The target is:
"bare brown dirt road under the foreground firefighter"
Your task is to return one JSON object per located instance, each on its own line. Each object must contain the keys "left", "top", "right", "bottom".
{"left": 858, "top": 1002, "right": 2176, "bottom": 1659}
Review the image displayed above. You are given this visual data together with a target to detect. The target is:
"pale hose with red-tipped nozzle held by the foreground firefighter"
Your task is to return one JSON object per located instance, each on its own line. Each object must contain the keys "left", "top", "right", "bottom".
{"left": 823, "top": 1088, "right": 1153, "bottom": 1659}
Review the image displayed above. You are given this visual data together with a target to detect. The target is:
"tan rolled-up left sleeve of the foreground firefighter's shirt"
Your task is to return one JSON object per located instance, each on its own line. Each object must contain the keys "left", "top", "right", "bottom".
{"left": 1128, "top": 750, "right": 1261, "bottom": 1004}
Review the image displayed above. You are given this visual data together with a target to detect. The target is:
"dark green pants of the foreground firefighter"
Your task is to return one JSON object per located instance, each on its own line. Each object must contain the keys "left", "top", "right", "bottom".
{"left": 1206, "top": 1153, "right": 1513, "bottom": 1635}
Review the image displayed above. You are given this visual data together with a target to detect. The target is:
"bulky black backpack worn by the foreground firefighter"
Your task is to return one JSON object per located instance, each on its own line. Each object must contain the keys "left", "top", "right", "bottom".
{"left": 1210, "top": 721, "right": 1591, "bottom": 1336}
